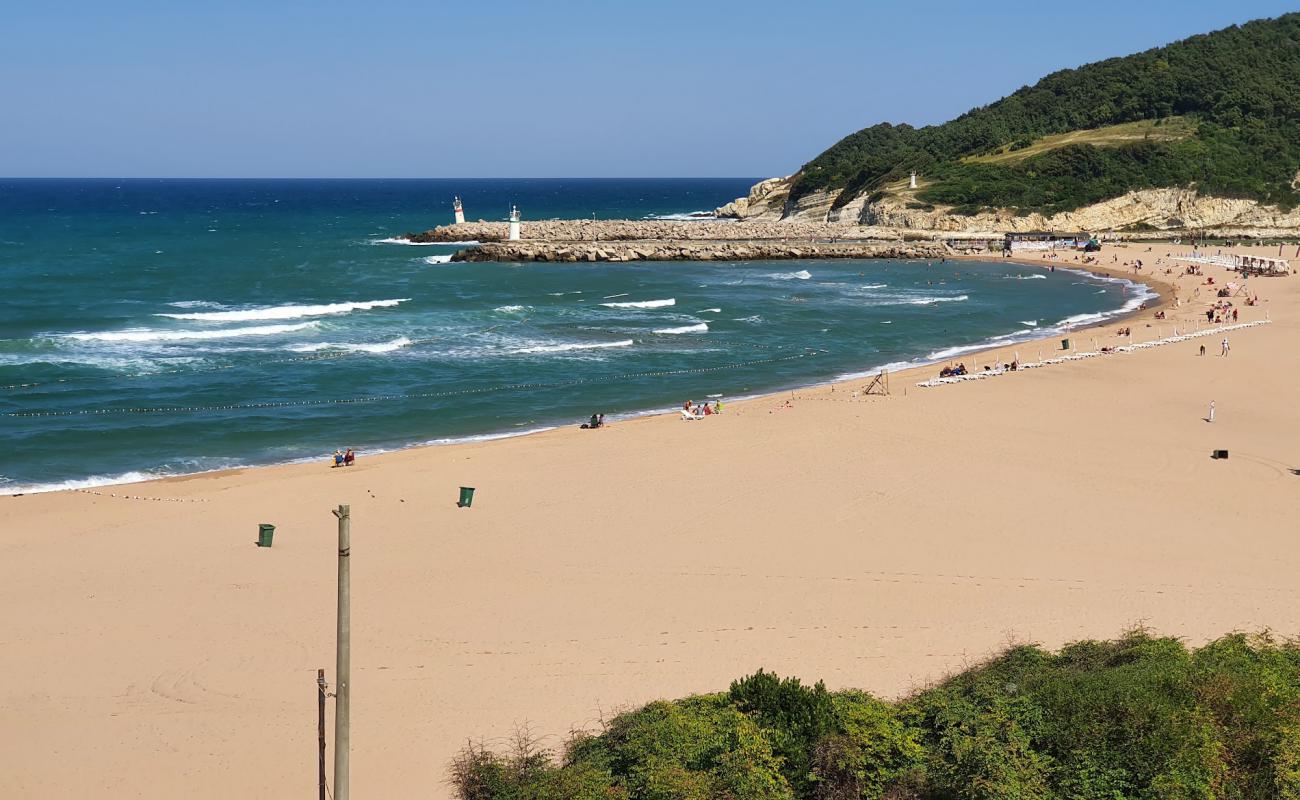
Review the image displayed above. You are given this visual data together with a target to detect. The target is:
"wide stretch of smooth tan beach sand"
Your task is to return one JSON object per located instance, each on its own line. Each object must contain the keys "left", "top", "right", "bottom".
{"left": 0, "top": 245, "right": 1300, "bottom": 797}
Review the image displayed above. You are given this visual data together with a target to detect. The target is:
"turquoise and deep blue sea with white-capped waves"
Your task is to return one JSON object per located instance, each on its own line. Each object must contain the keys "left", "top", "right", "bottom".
{"left": 0, "top": 178, "right": 1149, "bottom": 494}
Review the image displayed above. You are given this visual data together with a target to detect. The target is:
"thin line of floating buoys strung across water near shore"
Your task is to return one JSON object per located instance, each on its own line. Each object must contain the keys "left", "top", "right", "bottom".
{"left": 4, "top": 350, "right": 824, "bottom": 418}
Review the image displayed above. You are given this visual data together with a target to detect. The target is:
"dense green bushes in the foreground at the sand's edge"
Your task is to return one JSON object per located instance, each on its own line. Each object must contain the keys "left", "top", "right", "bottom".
{"left": 451, "top": 631, "right": 1300, "bottom": 800}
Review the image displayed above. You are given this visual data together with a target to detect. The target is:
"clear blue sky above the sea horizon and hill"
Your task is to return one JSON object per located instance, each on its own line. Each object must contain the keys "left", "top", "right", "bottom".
{"left": 0, "top": 0, "right": 1295, "bottom": 177}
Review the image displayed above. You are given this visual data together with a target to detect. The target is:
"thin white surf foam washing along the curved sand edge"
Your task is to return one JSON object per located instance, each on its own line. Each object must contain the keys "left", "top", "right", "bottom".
{"left": 0, "top": 255, "right": 1175, "bottom": 497}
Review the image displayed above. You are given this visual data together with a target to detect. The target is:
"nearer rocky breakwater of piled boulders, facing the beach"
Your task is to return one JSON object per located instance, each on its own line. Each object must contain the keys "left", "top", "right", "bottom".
{"left": 452, "top": 239, "right": 953, "bottom": 263}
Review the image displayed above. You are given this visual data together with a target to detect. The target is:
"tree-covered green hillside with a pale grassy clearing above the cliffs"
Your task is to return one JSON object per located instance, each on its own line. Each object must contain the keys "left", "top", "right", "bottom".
{"left": 792, "top": 13, "right": 1300, "bottom": 213}
